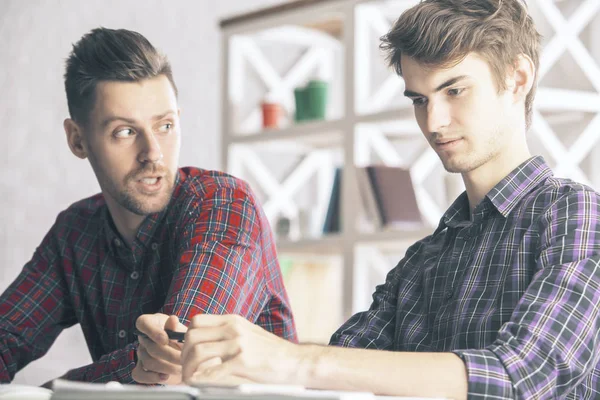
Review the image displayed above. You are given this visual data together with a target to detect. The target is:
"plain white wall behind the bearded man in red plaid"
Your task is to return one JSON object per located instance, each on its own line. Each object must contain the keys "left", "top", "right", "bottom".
{"left": 0, "top": 0, "right": 283, "bottom": 384}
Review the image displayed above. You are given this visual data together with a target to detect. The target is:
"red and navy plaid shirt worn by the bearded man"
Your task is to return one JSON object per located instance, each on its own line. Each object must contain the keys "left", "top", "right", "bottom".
{"left": 0, "top": 167, "right": 296, "bottom": 383}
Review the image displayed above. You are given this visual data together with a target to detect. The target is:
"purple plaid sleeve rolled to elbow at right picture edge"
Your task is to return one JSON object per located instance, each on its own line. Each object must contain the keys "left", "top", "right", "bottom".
{"left": 455, "top": 190, "right": 600, "bottom": 399}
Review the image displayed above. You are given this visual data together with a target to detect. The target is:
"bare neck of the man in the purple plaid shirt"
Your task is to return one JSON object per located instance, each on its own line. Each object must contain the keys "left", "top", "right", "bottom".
{"left": 462, "top": 145, "right": 531, "bottom": 212}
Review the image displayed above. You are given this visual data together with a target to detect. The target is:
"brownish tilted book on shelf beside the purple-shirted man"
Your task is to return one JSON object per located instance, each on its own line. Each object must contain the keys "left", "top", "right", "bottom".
{"left": 356, "top": 165, "right": 423, "bottom": 230}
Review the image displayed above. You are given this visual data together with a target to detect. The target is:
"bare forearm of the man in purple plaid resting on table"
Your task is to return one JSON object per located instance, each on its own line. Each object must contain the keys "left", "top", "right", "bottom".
{"left": 296, "top": 345, "right": 467, "bottom": 400}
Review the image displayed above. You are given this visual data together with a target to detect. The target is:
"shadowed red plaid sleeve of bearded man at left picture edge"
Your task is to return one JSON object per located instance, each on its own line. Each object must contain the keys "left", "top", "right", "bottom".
{"left": 0, "top": 216, "right": 77, "bottom": 383}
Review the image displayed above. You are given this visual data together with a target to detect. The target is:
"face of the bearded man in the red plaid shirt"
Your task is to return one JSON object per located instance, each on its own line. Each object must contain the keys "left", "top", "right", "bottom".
{"left": 84, "top": 75, "right": 180, "bottom": 215}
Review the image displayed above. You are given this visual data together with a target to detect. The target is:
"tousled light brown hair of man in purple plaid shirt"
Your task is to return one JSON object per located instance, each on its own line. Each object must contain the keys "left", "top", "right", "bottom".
{"left": 380, "top": 0, "right": 541, "bottom": 127}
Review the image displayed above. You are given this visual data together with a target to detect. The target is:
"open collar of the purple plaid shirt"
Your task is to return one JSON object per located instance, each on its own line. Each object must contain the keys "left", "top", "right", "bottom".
{"left": 436, "top": 156, "right": 553, "bottom": 233}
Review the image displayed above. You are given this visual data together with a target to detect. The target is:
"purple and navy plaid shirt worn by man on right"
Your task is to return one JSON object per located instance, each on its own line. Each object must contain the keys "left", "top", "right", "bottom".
{"left": 331, "top": 157, "right": 600, "bottom": 399}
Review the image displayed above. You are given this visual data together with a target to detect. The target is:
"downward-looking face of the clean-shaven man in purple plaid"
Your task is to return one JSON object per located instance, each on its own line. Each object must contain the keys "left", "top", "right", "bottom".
{"left": 401, "top": 53, "right": 514, "bottom": 173}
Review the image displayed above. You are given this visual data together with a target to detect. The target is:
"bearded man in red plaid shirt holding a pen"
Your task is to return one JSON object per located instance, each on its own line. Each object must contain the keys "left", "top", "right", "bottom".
{"left": 0, "top": 28, "right": 296, "bottom": 383}
